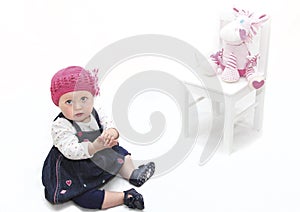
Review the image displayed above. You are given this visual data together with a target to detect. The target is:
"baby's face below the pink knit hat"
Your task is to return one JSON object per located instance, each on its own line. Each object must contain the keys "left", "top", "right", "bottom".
{"left": 58, "top": 91, "right": 94, "bottom": 122}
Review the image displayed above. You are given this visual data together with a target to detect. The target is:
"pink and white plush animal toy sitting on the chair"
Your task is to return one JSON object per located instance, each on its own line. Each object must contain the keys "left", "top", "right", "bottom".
{"left": 210, "top": 8, "right": 268, "bottom": 89}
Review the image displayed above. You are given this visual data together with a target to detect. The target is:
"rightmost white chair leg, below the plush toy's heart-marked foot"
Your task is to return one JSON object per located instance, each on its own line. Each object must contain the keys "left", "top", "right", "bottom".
{"left": 253, "top": 88, "right": 265, "bottom": 131}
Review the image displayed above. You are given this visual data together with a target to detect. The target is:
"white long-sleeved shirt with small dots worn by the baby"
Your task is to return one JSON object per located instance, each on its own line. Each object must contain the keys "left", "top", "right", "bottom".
{"left": 51, "top": 109, "right": 114, "bottom": 160}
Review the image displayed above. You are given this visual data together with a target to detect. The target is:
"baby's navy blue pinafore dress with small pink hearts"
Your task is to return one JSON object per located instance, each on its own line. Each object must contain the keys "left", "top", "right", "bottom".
{"left": 42, "top": 109, "right": 129, "bottom": 204}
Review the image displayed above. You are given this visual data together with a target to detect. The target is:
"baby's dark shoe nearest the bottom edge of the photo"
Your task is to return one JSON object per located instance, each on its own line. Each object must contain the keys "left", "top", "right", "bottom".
{"left": 124, "top": 188, "right": 144, "bottom": 210}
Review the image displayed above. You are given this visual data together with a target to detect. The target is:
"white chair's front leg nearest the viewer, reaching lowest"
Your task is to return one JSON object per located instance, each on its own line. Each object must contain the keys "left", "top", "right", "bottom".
{"left": 223, "top": 98, "right": 235, "bottom": 154}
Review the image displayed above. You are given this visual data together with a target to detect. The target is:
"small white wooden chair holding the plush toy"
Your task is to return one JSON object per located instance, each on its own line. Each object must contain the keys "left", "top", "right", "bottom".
{"left": 184, "top": 20, "right": 270, "bottom": 153}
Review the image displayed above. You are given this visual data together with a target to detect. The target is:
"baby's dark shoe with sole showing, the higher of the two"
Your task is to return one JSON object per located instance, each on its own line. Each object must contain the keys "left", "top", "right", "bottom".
{"left": 129, "top": 162, "right": 155, "bottom": 187}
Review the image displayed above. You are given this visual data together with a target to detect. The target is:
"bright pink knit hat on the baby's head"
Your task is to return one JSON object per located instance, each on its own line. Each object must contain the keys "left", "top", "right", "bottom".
{"left": 50, "top": 66, "right": 99, "bottom": 106}
